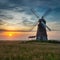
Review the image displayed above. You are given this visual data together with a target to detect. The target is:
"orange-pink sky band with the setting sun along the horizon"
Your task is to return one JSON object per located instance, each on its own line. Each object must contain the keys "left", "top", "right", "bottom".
{"left": 0, "top": 31, "right": 60, "bottom": 40}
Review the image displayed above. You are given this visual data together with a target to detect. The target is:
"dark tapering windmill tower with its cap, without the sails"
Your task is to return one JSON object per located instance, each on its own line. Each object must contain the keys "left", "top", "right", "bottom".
{"left": 36, "top": 18, "right": 48, "bottom": 40}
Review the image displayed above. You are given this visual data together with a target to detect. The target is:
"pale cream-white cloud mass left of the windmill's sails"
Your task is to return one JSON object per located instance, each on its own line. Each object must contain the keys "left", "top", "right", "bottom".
{"left": 0, "top": 8, "right": 34, "bottom": 26}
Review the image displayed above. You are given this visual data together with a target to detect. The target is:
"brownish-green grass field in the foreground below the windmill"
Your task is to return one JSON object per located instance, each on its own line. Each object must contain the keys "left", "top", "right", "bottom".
{"left": 0, "top": 41, "right": 60, "bottom": 60}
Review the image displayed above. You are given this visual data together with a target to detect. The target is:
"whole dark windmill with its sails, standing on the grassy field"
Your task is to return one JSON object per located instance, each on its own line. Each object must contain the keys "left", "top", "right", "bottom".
{"left": 29, "top": 9, "right": 51, "bottom": 40}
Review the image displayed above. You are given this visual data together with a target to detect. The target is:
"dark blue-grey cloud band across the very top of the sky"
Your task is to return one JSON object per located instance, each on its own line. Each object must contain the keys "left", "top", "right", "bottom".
{"left": 0, "top": 0, "right": 60, "bottom": 8}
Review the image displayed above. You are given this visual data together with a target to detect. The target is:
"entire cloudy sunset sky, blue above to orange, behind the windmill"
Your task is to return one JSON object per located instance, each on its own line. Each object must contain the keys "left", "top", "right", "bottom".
{"left": 0, "top": 0, "right": 60, "bottom": 40}
